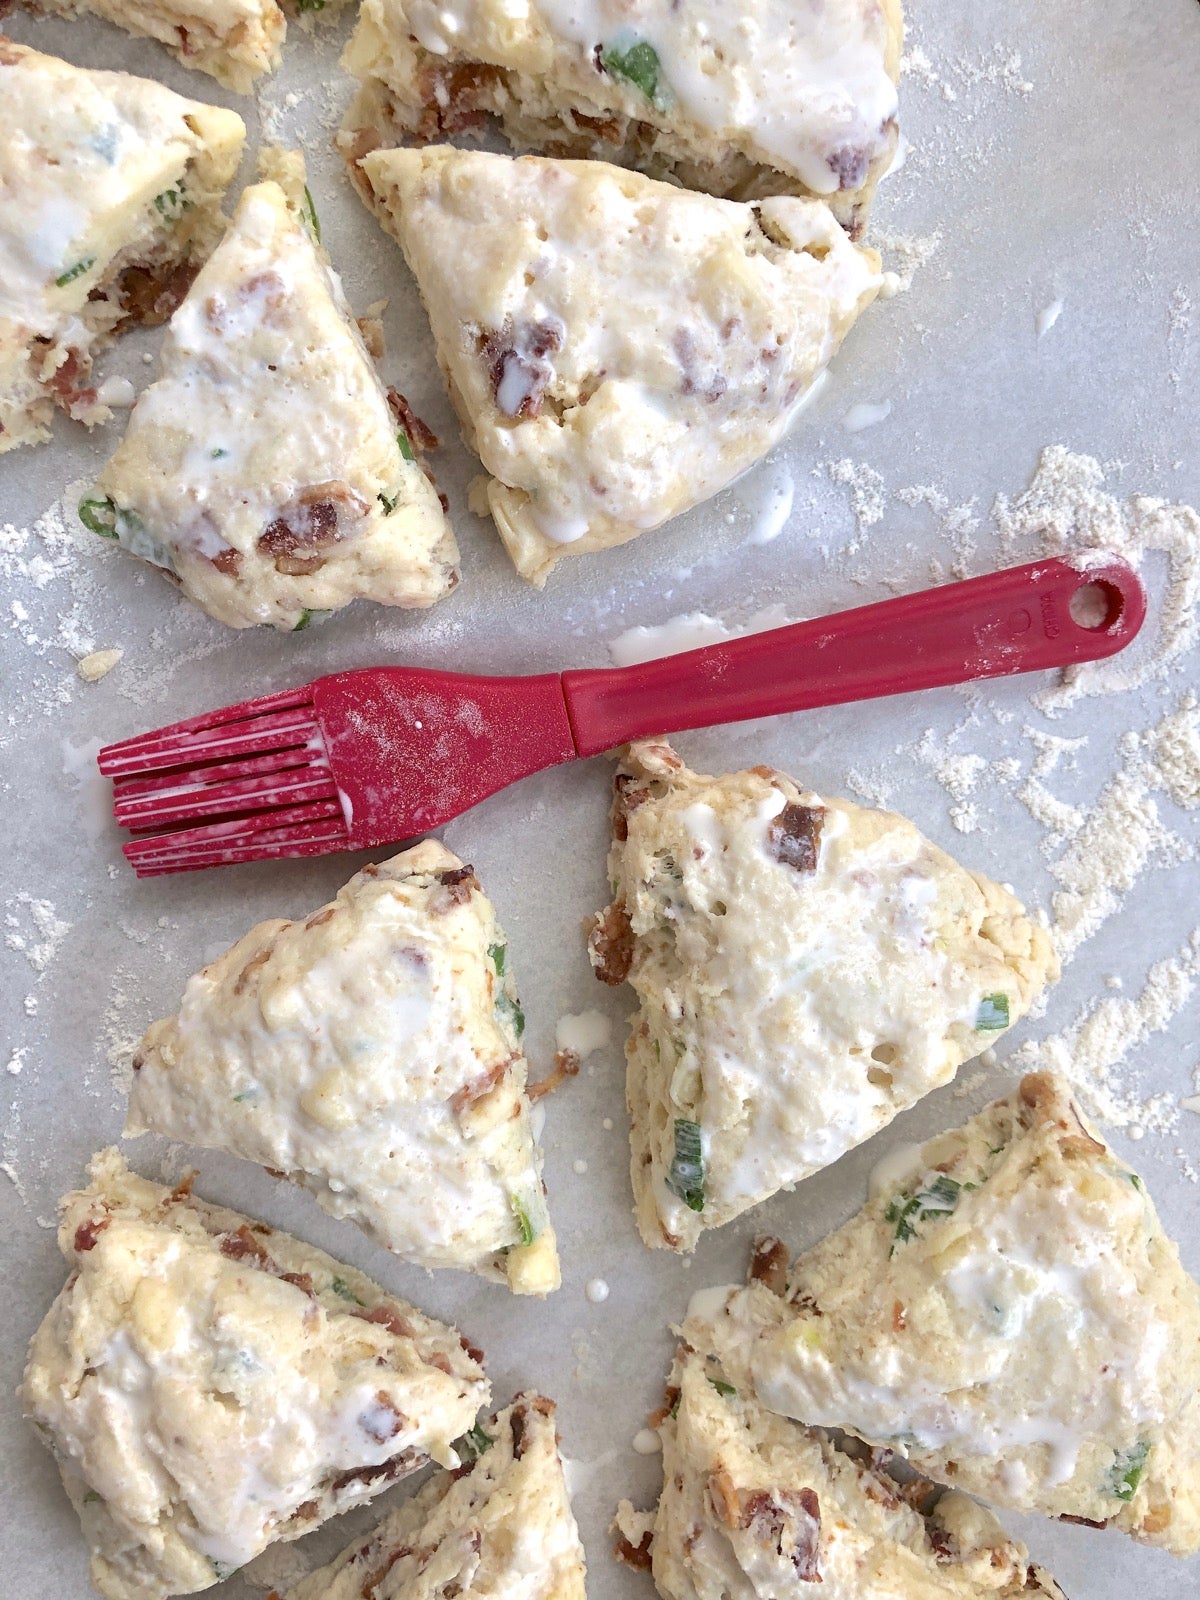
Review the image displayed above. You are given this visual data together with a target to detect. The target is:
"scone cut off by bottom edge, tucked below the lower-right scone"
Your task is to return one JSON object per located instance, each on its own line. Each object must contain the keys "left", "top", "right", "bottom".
{"left": 620, "top": 1346, "right": 1064, "bottom": 1600}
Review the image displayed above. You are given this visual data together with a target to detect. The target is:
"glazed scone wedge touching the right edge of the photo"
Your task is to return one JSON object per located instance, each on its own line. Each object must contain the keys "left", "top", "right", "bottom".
{"left": 750, "top": 1074, "right": 1200, "bottom": 1555}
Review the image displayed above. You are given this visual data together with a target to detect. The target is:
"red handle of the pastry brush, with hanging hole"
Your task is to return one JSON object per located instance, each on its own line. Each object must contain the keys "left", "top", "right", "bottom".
{"left": 562, "top": 560, "right": 1146, "bottom": 755}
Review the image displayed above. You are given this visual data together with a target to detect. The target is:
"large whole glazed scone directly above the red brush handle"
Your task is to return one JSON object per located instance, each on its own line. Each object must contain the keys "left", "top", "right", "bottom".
{"left": 352, "top": 146, "right": 880, "bottom": 586}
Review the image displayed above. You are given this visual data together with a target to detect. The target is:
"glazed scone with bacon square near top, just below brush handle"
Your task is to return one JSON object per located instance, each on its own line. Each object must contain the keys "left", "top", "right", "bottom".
{"left": 590, "top": 741, "right": 1058, "bottom": 1250}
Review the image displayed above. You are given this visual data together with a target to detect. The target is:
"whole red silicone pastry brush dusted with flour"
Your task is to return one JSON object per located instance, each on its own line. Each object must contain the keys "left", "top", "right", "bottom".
{"left": 99, "top": 558, "right": 1146, "bottom": 877}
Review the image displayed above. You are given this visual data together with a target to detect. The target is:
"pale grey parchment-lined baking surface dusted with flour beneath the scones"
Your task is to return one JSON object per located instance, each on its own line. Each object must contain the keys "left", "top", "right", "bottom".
{"left": 0, "top": 0, "right": 1200, "bottom": 1600}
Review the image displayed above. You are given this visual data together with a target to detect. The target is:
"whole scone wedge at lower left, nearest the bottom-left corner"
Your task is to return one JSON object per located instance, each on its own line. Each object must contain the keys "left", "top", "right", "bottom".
{"left": 21, "top": 1150, "right": 488, "bottom": 1600}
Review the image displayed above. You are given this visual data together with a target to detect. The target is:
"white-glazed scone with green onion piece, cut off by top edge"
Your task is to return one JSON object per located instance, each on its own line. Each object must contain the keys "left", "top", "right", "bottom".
{"left": 341, "top": 0, "right": 904, "bottom": 235}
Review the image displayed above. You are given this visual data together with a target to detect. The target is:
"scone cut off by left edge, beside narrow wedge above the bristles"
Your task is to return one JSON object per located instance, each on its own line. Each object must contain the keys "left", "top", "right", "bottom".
{"left": 0, "top": 35, "right": 246, "bottom": 453}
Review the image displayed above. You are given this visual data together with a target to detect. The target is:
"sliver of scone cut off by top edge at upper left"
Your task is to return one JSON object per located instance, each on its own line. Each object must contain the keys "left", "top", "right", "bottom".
{"left": 24, "top": 0, "right": 289, "bottom": 94}
